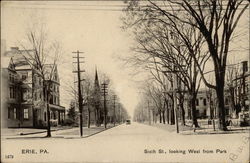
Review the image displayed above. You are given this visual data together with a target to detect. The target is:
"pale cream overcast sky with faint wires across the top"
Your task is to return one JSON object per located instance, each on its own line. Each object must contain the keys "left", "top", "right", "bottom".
{"left": 1, "top": 1, "right": 249, "bottom": 115}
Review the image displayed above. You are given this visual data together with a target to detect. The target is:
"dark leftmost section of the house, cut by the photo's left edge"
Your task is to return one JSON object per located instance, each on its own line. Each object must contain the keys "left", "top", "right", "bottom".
{"left": 1, "top": 57, "right": 33, "bottom": 127}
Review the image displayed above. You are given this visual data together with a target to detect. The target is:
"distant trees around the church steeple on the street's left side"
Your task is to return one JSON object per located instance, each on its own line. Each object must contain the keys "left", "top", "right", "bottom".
{"left": 66, "top": 70, "right": 129, "bottom": 132}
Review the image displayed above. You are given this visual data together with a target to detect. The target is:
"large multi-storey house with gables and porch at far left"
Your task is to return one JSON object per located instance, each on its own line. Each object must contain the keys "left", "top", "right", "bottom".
{"left": 1, "top": 47, "right": 65, "bottom": 127}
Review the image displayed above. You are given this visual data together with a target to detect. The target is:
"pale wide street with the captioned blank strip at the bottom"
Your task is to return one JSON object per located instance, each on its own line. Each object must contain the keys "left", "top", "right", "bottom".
{"left": 2, "top": 122, "right": 249, "bottom": 162}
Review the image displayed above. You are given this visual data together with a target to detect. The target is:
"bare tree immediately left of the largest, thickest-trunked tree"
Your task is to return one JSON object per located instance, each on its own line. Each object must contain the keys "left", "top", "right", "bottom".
{"left": 124, "top": 2, "right": 209, "bottom": 127}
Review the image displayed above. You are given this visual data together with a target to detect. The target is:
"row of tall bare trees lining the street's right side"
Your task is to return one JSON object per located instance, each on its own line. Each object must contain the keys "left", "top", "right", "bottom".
{"left": 122, "top": 0, "right": 249, "bottom": 130}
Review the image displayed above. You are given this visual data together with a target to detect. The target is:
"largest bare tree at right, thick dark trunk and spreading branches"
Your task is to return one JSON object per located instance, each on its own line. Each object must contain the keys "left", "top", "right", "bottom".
{"left": 123, "top": 0, "right": 249, "bottom": 130}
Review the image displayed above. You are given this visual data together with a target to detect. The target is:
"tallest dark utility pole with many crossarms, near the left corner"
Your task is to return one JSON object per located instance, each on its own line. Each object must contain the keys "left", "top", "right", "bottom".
{"left": 72, "top": 50, "right": 85, "bottom": 137}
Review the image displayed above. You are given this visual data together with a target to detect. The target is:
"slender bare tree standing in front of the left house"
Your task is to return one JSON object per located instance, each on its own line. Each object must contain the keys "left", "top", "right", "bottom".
{"left": 20, "top": 23, "right": 61, "bottom": 137}
